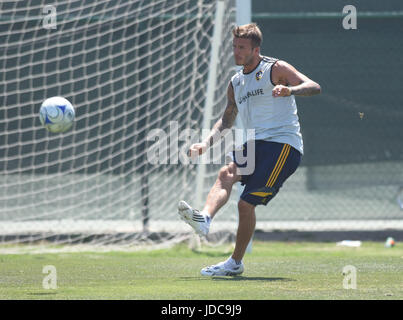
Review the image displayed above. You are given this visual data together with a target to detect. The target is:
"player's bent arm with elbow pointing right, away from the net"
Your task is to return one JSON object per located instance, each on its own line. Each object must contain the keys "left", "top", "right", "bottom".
{"left": 272, "top": 60, "right": 321, "bottom": 97}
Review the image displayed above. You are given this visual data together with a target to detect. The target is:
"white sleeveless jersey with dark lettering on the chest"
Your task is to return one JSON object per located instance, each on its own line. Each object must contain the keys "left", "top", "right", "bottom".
{"left": 231, "top": 57, "right": 304, "bottom": 154}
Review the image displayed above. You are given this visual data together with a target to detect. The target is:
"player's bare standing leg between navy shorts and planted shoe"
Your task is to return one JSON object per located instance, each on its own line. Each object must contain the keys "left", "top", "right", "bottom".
{"left": 232, "top": 199, "right": 256, "bottom": 262}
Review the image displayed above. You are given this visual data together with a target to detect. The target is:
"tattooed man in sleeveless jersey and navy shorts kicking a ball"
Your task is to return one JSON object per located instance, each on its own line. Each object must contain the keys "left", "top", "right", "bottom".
{"left": 178, "top": 23, "right": 321, "bottom": 276}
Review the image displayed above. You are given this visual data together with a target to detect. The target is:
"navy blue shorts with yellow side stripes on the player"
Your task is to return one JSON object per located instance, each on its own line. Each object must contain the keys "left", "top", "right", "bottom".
{"left": 232, "top": 140, "right": 302, "bottom": 206}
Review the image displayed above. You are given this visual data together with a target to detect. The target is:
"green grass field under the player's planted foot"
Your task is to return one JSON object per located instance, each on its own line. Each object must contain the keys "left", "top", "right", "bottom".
{"left": 0, "top": 242, "right": 403, "bottom": 300}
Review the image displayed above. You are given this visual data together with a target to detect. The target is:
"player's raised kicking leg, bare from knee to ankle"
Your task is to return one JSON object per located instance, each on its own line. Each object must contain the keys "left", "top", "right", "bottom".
{"left": 202, "top": 162, "right": 241, "bottom": 218}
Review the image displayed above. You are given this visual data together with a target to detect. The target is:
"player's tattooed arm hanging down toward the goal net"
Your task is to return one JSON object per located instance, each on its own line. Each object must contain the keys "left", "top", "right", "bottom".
{"left": 188, "top": 82, "right": 238, "bottom": 156}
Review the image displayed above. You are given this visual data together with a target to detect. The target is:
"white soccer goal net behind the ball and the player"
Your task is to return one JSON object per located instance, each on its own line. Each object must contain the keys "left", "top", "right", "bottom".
{"left": 0, "top": 0, "right": 240, "bottom": 248}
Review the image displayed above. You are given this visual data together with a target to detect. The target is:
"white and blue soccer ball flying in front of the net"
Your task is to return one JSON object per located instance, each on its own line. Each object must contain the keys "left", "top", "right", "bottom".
{"left": 39, "top": 97, "right": 75, "bottom": 133}
